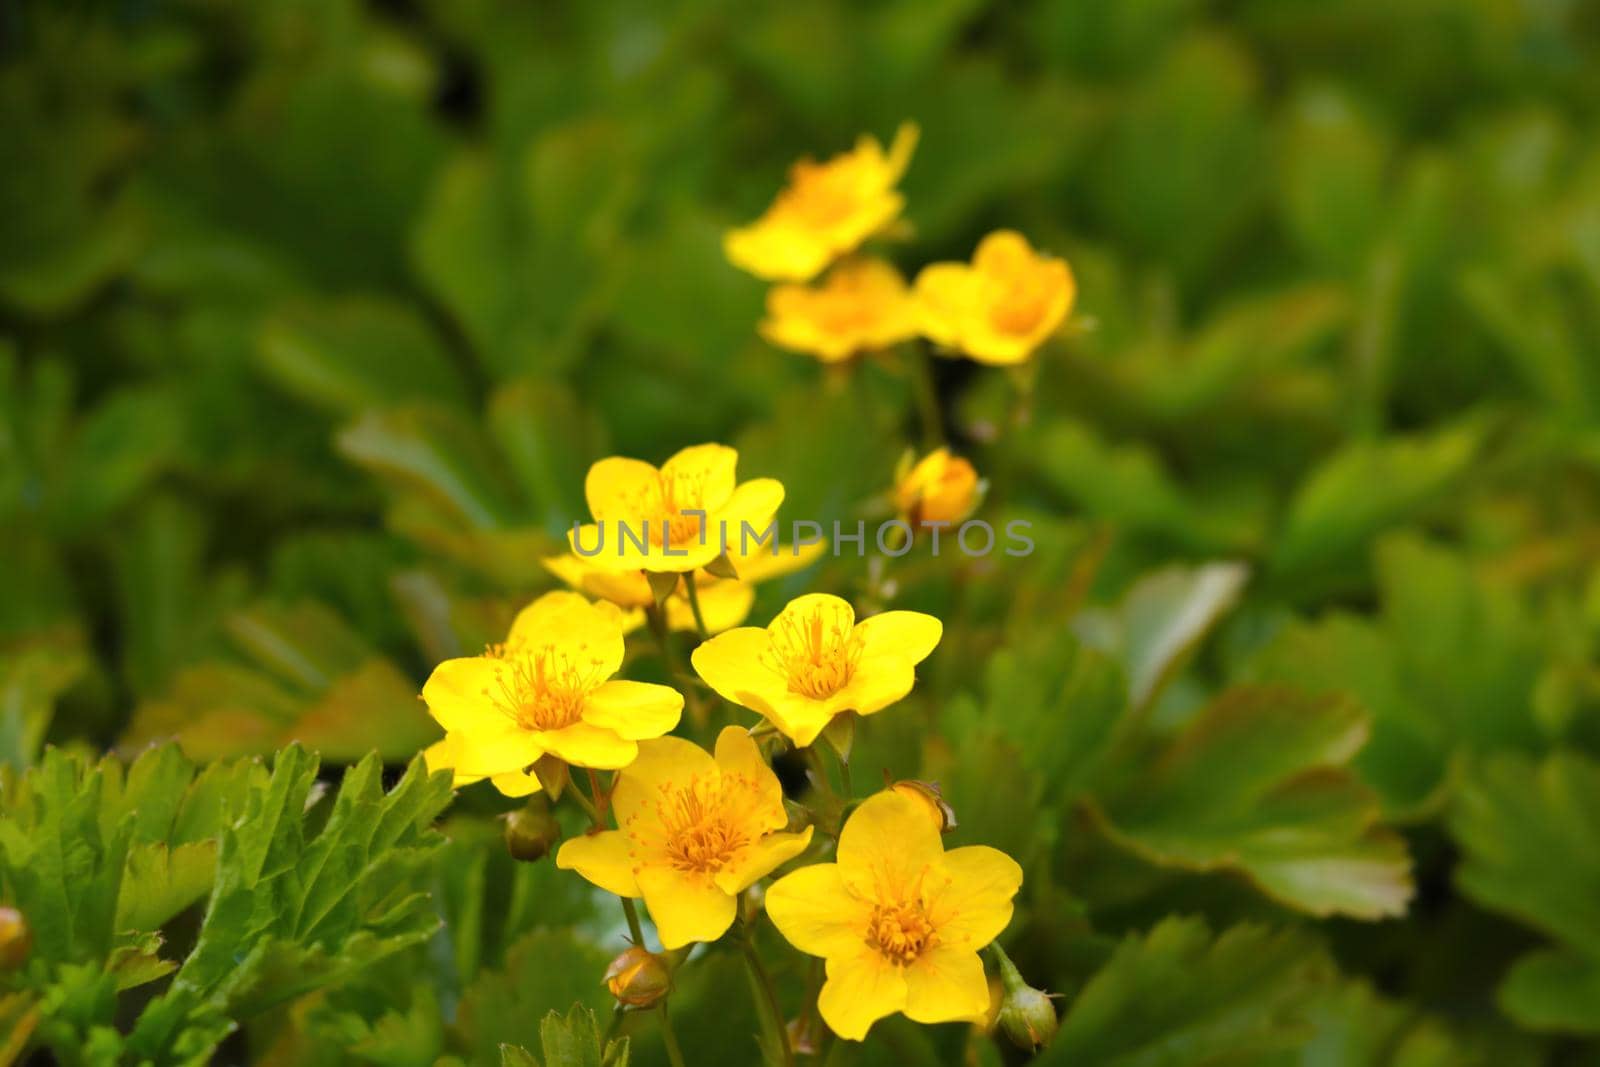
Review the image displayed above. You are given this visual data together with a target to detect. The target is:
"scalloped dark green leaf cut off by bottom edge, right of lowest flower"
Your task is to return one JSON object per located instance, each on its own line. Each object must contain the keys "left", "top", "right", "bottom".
{"left": 1034, "top": 918, "right": 1331, "bottom": 1067}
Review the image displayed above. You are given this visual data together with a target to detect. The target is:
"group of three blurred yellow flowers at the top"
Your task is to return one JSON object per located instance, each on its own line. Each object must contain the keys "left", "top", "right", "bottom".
{"left": 723, "top": 123, "right": 1077, "bottom": 365}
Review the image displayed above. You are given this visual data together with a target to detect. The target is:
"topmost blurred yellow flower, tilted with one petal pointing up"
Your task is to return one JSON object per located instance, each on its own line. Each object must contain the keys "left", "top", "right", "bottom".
{"left": 722, "top": 123, "right": 917, "bottom": 282}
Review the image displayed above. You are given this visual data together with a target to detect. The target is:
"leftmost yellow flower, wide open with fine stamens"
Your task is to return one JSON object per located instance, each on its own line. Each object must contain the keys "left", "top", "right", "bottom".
{"left": 422, "top": 592, "right": 683, "bottom": 797}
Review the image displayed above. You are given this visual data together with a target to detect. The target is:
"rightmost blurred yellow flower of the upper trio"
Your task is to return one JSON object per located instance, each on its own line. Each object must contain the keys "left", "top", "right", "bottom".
{"left": 917, "top": 230, "right": 1077, "bottom": 363}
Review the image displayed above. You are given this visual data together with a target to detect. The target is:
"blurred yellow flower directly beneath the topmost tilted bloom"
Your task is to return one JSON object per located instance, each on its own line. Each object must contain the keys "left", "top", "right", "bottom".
{"left": 760, "top": 259, "right": 917, "bottom": 363}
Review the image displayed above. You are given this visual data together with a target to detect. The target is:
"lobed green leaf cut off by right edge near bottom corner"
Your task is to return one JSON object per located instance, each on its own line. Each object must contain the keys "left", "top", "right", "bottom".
{"left": 1450, "top": 752, "right": 1600, "bottom": 1033}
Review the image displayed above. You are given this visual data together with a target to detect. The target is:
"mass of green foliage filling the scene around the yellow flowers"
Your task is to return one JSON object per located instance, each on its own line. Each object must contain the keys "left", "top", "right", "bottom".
{"left": 0, "top": 0, "right": 1600, "bottom": 1067}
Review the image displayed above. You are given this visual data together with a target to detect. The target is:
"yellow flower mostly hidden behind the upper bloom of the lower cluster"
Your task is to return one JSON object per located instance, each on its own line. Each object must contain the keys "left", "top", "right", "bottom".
{"left": 544, "top": 537, "right": 826, "bottom": 633}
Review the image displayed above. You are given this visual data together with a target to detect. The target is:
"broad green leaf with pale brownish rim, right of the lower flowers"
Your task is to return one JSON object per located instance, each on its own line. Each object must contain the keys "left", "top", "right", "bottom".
{"left": 1101, "top": 686, "right": 1411, "bottom": 920}
